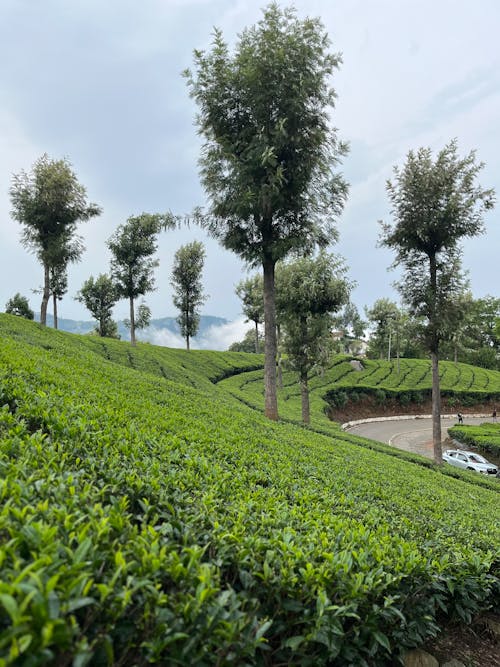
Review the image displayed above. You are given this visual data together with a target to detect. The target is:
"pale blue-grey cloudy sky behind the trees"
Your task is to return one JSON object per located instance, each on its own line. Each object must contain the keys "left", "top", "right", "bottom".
{"left": 0, "top": 0, "right": 500, "bottom": 348}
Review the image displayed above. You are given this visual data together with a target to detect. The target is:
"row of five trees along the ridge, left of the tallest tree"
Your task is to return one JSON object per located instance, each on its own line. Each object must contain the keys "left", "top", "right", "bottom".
{"left": 7, "top": 155, "right": 209, "bottom": 349}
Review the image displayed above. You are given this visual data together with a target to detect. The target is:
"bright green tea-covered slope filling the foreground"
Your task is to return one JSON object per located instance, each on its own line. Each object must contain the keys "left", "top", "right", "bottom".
{"left": 0, "top": 315, "right": 500, "bottom": 667}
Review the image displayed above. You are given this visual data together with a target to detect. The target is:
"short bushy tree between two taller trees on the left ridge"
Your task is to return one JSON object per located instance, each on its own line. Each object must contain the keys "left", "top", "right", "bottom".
{"left": 75, "top": 273, "right": 119, "bottom": 338}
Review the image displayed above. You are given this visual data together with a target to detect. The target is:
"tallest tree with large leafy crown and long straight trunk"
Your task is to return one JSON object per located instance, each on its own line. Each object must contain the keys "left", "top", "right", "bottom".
{"left": 185, "top": 3, "right": 347, "bottom": 419}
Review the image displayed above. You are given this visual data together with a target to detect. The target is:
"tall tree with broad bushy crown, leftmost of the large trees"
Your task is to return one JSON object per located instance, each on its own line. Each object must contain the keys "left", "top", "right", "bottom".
{"left": 9, "top": 154, "right": 101, "bottom": 325}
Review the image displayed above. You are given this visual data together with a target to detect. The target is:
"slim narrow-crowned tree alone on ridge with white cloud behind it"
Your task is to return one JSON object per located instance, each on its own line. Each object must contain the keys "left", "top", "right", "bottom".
{"left": 171, "top": 241, "right": 206, "bottom": 351}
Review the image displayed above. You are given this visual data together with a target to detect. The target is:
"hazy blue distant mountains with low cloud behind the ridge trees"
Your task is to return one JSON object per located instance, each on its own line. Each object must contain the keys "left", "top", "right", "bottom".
{"left": 35, "top": 313, "right": 229, "bottom": 342}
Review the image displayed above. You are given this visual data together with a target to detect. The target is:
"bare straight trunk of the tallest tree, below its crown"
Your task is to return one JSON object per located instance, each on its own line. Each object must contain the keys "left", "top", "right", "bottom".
{"left": 262, "top": 257, "right": 278, "bottom": 420}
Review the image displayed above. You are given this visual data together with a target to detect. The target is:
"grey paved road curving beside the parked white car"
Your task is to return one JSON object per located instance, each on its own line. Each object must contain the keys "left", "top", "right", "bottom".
{"left": 348, "top": 415, "right": 491, "bottom": 458}
